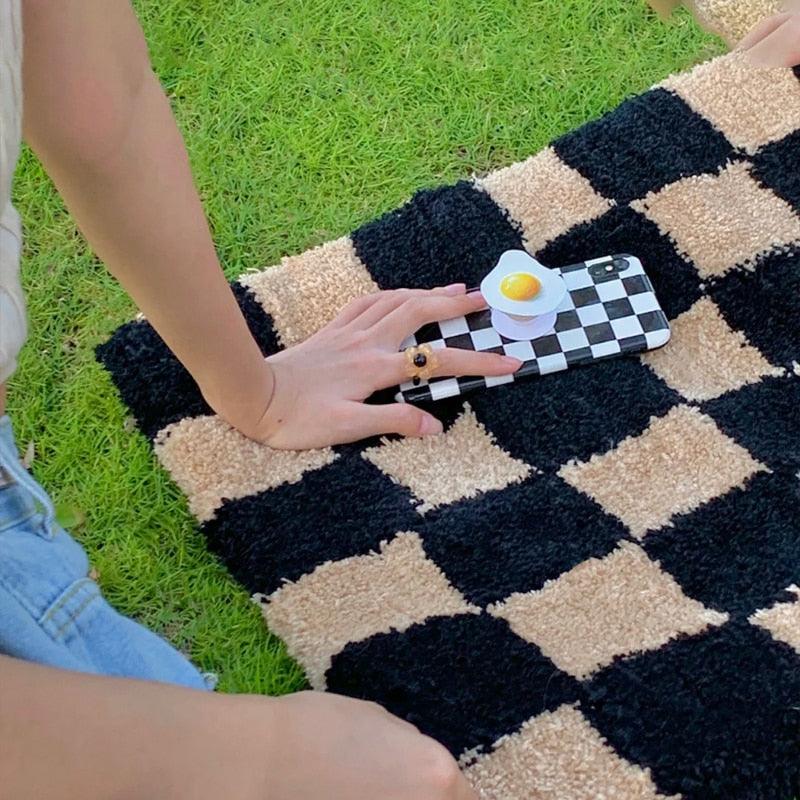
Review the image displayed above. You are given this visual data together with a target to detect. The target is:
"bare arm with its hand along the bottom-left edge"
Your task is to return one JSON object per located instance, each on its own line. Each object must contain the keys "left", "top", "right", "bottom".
{"left": 0, "top": 655, "right": 477, "bottom": 800}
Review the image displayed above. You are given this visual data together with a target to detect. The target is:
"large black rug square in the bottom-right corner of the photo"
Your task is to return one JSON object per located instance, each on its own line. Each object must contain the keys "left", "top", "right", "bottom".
{"left": 582, "top": 622, "right": 800, "bottom": 800}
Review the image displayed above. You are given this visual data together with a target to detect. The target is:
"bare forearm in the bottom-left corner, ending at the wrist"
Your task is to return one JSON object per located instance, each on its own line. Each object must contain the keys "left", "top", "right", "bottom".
{"left": 0, "top": 656, "right": 271, "bottom": 800}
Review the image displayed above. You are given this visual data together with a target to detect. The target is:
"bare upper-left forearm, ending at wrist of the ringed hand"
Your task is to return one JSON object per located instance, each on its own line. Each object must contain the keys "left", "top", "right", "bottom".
{"left": 24, "top": 0, "right": 272, "bottom": 424}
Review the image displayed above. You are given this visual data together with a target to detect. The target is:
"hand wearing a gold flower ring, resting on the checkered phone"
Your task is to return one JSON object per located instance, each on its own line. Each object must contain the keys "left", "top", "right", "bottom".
{"left": 244, "top": 284, "right": 522, "bottom": 450}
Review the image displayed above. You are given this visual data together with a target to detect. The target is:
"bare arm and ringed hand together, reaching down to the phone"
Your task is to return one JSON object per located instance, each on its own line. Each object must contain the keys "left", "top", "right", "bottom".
{"left": 23, "top": 0, "right": 520, "bottom": 448}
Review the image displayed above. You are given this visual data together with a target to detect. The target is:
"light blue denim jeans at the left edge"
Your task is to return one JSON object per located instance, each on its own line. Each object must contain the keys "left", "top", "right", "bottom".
{"left": 0, "top": 416, "right": 211, "bottom": 689}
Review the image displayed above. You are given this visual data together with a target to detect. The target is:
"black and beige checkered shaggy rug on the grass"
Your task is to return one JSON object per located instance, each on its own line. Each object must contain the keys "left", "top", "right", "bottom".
{"left": 99, "top": 54, "right": 800, "bottom": 800}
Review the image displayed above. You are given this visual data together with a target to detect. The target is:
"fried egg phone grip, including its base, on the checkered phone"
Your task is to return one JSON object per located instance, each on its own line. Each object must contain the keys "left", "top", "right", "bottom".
{"left": 481, "top": 250, "right": 567, "bottom": 341}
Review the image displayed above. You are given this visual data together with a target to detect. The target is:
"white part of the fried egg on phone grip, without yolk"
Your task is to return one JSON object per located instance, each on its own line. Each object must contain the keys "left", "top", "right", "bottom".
{"left": 481, "top": 250, "right": 567, "bottom": 317}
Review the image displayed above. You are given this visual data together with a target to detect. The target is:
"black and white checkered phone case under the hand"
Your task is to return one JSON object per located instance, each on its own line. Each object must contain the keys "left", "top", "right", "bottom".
{"left": 395, "top": 254, "right": 670, "bottom": 403}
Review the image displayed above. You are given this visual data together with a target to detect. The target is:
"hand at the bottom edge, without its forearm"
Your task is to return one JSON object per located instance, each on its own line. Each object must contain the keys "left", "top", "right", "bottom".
{"left": 252, "top": 692, "right": 477, "bottom": 800}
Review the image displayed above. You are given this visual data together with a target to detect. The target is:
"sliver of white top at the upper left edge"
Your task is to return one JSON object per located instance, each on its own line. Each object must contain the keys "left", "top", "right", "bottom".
{"left": 0, "top": 0, "right": 27, "bottom": 384}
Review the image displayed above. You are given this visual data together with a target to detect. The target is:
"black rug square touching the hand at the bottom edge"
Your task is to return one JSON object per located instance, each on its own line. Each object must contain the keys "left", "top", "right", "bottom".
{"left": 326, "top": 614, "right": 580, "bottom": 757}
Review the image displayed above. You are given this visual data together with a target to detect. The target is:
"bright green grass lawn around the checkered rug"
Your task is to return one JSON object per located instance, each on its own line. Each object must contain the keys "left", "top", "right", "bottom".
{"left": 10, "top": 0, "right": 720, "bottom": 693}
